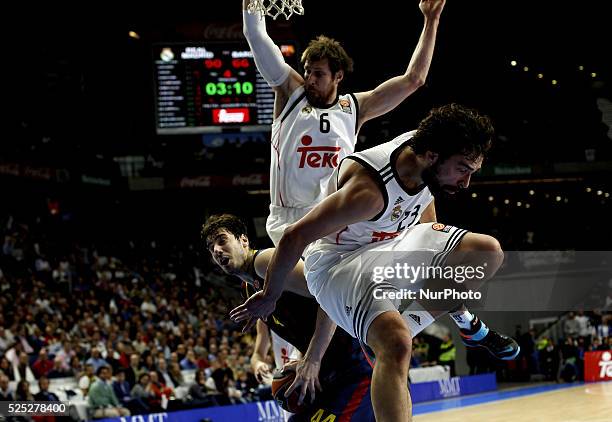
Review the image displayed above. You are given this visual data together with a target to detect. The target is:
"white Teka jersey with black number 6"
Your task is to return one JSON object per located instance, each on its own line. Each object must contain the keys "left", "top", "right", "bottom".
{"left": 270, "top": 86, "right": 359, "bottom": 208}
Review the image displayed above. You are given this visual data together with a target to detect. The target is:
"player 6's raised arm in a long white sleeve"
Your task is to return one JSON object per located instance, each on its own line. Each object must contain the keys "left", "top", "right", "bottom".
{"left": 242, "top": 0, "right": 304, "bottom": 113}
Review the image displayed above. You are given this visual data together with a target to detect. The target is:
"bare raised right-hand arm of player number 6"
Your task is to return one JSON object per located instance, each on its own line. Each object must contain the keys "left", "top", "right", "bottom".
{"left": 355, "top": 0, "right": 446, "bottom": 125}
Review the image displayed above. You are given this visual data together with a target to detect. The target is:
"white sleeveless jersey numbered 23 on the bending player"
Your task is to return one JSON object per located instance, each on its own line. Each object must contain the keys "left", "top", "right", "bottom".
{"left": 319, "top": 131, "right": 433, "bottom": 250}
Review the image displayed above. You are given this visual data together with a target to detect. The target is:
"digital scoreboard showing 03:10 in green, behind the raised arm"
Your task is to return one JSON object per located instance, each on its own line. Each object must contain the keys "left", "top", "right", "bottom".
{"left": 153, "top": 42, "right": 297, "bottom": 135}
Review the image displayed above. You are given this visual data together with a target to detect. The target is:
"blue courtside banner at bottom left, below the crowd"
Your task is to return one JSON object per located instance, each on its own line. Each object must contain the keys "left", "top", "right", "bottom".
{"left": 96, "top": 400, "right": 285, "bottom": 422}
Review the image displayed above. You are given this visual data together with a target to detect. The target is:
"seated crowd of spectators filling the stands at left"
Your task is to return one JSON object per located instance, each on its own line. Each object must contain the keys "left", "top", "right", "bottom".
{"left": 0, "top": 213, "right": 269, "bottom": 417}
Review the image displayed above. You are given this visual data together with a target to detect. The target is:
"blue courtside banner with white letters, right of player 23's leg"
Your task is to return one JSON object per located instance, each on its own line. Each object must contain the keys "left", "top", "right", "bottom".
{"left": 410, "top": 373, "right": 497, "bottom": 403}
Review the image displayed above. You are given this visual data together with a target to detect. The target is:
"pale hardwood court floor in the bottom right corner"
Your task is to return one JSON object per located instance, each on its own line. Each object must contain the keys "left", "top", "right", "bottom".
{"left": 414, "top": 382, "right": 612, "bottom": 422}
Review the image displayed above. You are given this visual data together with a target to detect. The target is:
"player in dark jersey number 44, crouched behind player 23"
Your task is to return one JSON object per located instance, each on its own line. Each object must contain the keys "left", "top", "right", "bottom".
{"left": 201, "top": 214, "right": 374, "bottom": 421}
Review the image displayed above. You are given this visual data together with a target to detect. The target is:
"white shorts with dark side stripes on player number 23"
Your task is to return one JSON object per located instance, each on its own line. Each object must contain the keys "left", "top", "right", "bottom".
{"left": 304, "top": 223, "right": 468, "bottom": 344}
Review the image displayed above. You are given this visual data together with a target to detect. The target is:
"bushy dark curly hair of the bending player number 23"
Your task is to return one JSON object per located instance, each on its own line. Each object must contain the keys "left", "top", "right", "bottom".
{"left": 410, "top": 103, "right": 494, "bottom": 162}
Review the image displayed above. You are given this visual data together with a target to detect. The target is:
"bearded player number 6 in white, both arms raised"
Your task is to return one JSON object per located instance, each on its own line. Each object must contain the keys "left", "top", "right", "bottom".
{"left": 243, "top": 0, "right": 446, "bottom": 404}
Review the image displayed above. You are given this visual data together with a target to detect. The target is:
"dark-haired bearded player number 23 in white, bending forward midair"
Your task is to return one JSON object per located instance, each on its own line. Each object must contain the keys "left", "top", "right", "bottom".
{"left": 230, "top": 104, "right": 519, "bottom": 422}
